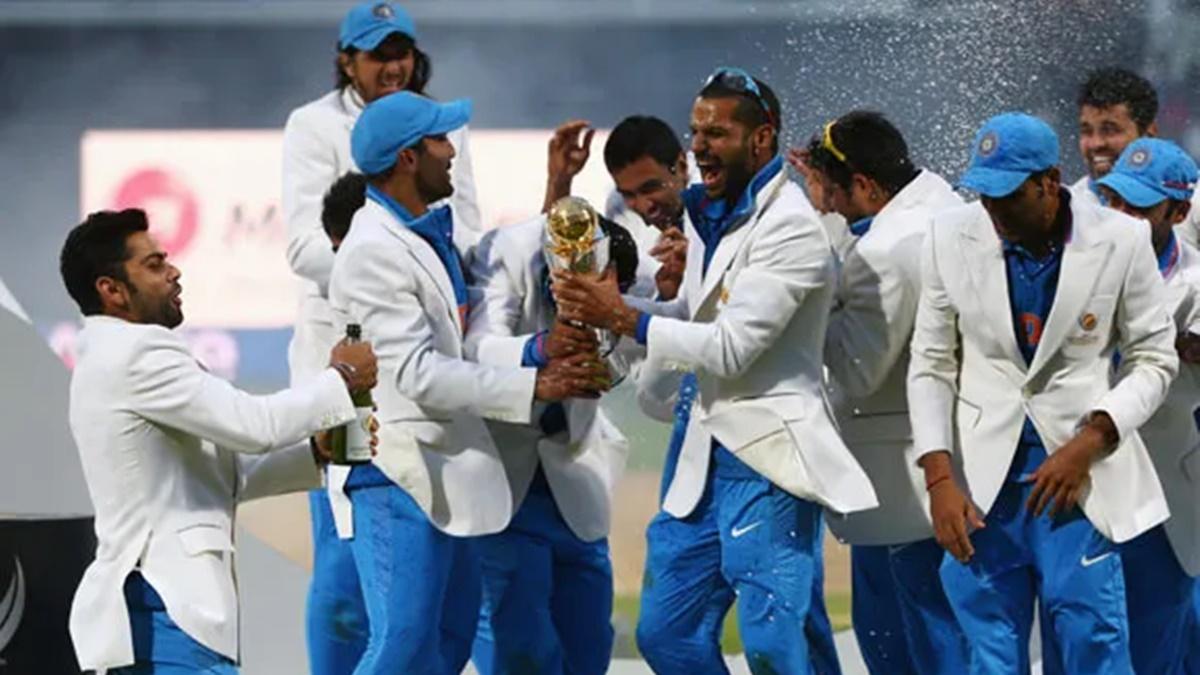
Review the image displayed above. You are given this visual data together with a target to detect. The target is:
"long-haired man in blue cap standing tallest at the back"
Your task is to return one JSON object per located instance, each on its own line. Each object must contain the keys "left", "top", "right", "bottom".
{"left": 283, "top": 0, "right": 480, "bottom": 675}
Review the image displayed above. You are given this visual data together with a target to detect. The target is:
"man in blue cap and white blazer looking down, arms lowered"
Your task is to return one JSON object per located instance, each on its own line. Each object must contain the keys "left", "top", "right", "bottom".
{"left": 908, "top": 113, "right": 1178, "bottom": 673}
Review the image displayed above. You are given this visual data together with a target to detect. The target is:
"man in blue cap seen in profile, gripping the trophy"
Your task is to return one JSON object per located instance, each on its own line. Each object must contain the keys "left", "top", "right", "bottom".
{"left": 329, "top": 91, "right": 602, "bottom": 675}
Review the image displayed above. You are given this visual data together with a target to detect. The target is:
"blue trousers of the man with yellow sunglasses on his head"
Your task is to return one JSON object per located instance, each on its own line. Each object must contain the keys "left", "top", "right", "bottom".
{"left": 851, "top": 539, "right": 970, "bottom": 675}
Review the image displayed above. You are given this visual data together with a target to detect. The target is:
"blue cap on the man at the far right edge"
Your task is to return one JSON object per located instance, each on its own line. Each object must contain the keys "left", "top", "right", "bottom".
{"left": 1097, "top": 138, "right": 1198, "bottom": 209}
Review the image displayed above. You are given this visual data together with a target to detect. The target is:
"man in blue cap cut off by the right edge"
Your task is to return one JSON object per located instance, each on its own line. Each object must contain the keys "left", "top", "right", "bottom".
{"left": 1098, "top": 138, "right": 1200, "bottom": 673}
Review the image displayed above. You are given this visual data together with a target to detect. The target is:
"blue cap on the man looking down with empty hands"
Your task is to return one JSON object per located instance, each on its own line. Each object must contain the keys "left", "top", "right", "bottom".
{"left": 959, "top": 113, "right": 1058, "bottom": 199}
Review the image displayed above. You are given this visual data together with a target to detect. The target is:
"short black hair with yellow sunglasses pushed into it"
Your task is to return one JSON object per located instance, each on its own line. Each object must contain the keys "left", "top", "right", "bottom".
{"left": 809, "top": 110, "right": 917, "bottom": 195}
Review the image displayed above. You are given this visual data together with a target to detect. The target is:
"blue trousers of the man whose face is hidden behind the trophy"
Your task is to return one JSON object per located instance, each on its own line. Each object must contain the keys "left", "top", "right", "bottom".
{"left": 472, "top": 468, "right": 613, "bottom": 675}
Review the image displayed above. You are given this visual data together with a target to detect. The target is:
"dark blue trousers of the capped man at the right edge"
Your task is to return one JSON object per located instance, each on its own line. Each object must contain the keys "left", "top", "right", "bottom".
{"left": 1120, "top": 525, "right": 1198, "bottom": 675}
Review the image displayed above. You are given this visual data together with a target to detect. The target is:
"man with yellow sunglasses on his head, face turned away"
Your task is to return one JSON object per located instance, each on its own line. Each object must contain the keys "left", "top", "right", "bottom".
{"left": 803, "top": 110, "right": 967, "bottom": 675}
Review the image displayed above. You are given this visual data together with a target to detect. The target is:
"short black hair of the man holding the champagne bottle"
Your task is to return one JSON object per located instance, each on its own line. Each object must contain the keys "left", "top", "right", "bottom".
{"left": 59, "top": 209, "right": 150, "bottom": 316}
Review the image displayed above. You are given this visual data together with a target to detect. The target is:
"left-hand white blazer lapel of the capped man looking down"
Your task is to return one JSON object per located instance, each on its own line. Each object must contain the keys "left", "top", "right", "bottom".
{"left": 959, "top": 208, "right": 1026, "bottom": 374}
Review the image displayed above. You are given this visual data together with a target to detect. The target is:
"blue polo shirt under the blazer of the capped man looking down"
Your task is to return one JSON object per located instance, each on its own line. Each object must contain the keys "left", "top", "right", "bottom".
{"left": 1001, "top": 190, "right": 1072, "bottom": 482}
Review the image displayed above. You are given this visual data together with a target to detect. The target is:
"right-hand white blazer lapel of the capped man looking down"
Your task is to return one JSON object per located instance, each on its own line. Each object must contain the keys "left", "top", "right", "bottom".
{"left": 1028, "top": 219, "right": 1112, "bottom": 378}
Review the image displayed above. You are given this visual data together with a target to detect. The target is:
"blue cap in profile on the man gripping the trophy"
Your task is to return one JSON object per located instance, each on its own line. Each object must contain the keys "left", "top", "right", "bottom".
{"left": 350, "top": 91, "right": 470, "bottom": 175}
